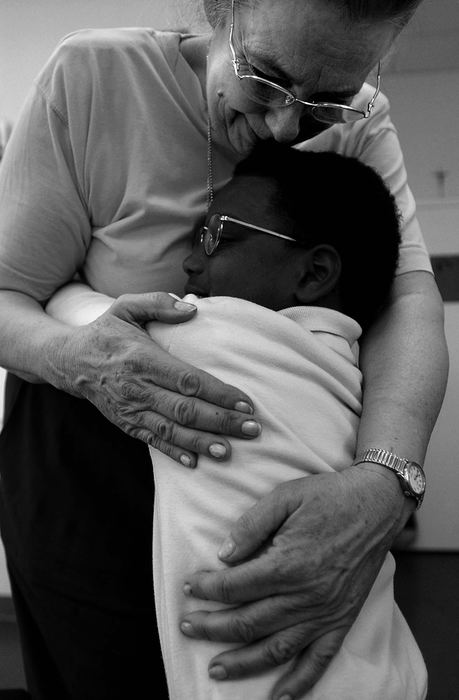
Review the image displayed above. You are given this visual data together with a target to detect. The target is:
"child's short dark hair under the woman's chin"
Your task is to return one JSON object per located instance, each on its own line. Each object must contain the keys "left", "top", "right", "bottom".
{"left": 234, "top": 141, "right": 400, "bottom": 327}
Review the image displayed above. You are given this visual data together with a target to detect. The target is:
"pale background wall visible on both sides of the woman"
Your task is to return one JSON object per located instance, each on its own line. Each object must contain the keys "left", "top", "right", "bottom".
{"left": 0, "top": 0, "right": 459, "bottom": 595}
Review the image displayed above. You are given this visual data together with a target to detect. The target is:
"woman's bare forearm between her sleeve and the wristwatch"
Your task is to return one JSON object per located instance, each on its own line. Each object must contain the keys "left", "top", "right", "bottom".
{"left": 357, "top": 272, "right": 448, "bottom": 514}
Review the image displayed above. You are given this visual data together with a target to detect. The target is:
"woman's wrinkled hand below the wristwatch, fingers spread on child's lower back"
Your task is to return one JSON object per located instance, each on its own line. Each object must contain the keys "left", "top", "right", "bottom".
{"left": 181, "top": 465, "right": 406, "bottom": 700}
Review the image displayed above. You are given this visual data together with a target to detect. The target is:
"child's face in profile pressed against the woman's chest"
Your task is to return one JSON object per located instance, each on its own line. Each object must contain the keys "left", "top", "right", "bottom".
{"left": 183, "top": 176, "right": 306, "bottom": 311}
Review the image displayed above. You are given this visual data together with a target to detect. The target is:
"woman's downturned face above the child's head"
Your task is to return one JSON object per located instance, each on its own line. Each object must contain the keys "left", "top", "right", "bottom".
{"left": 207, "top": 0, "right": 397, "bottom": 156}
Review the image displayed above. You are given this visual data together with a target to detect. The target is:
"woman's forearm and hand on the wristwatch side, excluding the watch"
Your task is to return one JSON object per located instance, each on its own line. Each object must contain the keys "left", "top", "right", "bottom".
{"left": 182, "top": 272, "right": 448, "bottom": 700}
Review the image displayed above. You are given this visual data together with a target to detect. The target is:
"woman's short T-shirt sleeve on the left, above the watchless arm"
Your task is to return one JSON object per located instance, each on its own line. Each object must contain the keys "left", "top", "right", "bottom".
{"left": 0, "top": 39, "right": 91, "bottom": 301}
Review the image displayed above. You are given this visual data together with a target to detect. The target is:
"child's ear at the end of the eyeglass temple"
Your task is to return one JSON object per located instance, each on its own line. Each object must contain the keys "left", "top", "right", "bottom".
{"left": 296, "top": 245, "right": 341, "bottom": 304}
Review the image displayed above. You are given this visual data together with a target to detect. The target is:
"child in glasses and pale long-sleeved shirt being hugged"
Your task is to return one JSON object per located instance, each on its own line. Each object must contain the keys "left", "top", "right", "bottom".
{"left": 49, "top": 144, "right": 426, "bottom": 700}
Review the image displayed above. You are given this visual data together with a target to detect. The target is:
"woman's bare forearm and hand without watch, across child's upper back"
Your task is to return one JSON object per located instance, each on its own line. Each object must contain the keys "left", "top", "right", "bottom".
{"left": 0, "top": 290, "right": 258, "bottom": 466}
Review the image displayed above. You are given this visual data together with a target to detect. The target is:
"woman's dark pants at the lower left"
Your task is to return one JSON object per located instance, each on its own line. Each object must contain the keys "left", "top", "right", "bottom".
{"left": 0, "top": 377, "right": 167, "bottom": 700}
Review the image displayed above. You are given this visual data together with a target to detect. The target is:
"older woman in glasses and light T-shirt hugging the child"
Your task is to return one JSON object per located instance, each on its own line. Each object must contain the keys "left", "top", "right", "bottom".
{"left": 0, "top": 0, "right": 447, "bottom": 700}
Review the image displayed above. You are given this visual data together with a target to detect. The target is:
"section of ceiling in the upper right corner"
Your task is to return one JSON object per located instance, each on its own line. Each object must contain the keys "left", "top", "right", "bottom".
{"left": 386, "top": 0, "right": 459, "bottom": 72}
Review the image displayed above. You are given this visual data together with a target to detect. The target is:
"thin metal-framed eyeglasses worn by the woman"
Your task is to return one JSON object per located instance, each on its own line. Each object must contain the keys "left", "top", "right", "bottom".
{"left": 229, "top": 0, "right": 381, "bottom": 124}
